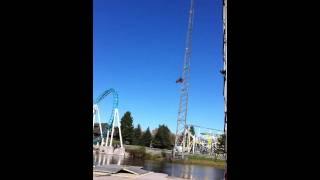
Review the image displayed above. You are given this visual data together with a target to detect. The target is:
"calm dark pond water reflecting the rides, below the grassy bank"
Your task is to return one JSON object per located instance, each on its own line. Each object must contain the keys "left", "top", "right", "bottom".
{"left": 93, "top": 154, "right": 224, "bottom": 180}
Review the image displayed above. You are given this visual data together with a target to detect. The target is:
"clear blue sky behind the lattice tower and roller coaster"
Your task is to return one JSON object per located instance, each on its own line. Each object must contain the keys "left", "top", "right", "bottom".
{"left": 93, "top": 0, "right": 224, "bottom": 132}
